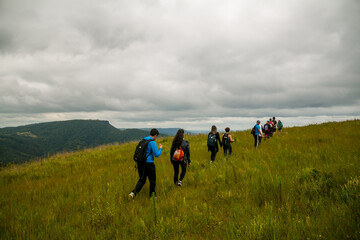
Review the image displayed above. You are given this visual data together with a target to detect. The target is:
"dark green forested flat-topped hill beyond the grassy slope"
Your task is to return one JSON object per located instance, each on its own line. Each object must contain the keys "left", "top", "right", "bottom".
{"left": 0, "top": 120, "right": 148, "bottom": 165}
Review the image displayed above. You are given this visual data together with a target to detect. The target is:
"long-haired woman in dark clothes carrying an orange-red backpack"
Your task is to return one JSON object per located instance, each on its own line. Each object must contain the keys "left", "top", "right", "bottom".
{"left": 170, "top": 129, "right": 191, "bottom": 187}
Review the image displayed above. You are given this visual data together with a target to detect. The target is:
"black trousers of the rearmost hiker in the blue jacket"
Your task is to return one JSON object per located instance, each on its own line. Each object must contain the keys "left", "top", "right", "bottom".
{"left": 133, "top": 163, "right": 156, "bottom": 197}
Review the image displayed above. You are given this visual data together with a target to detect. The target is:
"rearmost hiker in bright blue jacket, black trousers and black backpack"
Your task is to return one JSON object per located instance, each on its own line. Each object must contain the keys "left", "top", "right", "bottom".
{"left": 129, "top": 128, "right": 162, "bottom": 199}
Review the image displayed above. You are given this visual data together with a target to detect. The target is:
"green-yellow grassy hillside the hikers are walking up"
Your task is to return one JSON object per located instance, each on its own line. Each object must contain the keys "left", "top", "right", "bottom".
{"left": 0, "top": 120, "right": 360, "bottom": 239}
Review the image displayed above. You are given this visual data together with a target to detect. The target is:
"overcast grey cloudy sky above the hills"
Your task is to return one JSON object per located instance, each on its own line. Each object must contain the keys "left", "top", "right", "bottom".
{"left": 0, "top": 0, "right": 360, "bottom": 129}
